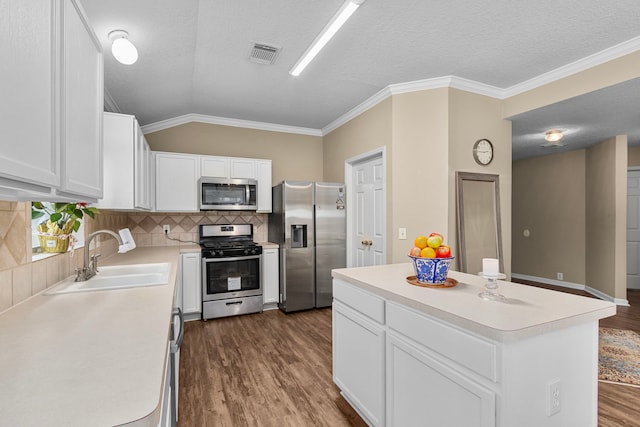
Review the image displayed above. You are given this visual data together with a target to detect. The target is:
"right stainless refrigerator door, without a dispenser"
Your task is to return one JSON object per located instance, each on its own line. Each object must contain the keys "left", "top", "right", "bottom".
{"left": 315, "top": 182, "right": 347, "bottom": 307}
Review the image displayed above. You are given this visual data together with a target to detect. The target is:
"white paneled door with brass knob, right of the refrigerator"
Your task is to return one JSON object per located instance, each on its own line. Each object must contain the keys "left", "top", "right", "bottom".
{"left": 352, "top": 157, "right": 385, "bottom": 267}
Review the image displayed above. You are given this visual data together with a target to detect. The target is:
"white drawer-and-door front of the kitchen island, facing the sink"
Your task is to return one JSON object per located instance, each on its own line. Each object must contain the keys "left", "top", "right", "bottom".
{"left": 333, "top": 280, "right": 498, "bottom": 427}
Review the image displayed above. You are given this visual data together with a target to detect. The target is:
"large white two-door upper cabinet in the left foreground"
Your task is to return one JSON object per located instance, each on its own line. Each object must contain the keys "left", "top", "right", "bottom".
{"left": 0, "top": 0, "right": 103, "bottom": 201}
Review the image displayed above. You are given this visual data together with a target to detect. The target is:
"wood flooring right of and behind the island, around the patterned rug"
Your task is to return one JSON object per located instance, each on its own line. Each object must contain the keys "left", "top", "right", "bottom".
{"left": 513, "top": 279, "right": 640, "bottom": 427}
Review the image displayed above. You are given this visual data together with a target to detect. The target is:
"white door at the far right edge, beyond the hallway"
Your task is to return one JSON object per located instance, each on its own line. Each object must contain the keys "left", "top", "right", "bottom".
{"left": 627, "top": 170, "right": 640, "bottom": 289}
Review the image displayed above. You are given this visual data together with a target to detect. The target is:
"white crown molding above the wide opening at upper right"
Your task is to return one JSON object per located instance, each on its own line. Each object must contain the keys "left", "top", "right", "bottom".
{"left": 504, "top": 36, "right": 640, "bottom": 98}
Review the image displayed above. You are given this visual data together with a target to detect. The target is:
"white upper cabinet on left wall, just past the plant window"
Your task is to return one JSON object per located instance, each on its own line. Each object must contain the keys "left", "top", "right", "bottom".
{"left": 97, "top": 113, "right": 151, "bottom": 210}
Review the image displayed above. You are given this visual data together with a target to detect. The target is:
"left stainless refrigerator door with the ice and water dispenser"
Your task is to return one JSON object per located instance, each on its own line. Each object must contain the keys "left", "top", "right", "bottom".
{"left": 280, "top": 181, "right": 315, "bottom": 313}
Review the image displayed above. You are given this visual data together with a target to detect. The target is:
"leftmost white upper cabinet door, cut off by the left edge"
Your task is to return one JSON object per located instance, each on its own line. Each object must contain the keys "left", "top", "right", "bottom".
{"left": 0, "top": 0, "right": 60, "bottom": 187}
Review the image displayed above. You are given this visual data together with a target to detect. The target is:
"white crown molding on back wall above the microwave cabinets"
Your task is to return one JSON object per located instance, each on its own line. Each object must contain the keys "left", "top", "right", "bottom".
{"left": 142, "top": 114, "right": 322, "bottom": 136}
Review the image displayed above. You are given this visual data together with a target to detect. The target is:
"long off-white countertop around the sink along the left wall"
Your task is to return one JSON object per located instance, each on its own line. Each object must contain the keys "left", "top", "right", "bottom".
{"left": 0, "top": 246, "right": 186, "bottom": 427}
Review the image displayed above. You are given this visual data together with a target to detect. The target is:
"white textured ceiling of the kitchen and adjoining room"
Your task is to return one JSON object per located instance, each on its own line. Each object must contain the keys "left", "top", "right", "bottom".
{"left": 82, "top": 0, "right": 640, "bottom": 158}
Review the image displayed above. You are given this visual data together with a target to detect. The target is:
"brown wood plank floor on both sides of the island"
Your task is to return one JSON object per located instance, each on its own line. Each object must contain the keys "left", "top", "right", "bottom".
{"left": 178, "top": 283, "right": 640, "bottom": 427}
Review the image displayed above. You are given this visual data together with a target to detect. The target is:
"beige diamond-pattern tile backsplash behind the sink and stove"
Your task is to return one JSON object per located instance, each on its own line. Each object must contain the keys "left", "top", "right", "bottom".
{"left": 0, "top": 206, "right": 268, "bottom": 311}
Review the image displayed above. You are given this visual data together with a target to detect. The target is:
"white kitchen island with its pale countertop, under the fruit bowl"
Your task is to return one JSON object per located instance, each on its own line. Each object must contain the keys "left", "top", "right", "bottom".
{"left": 333, "top": 263, "right": 616, "bottom": 427}
